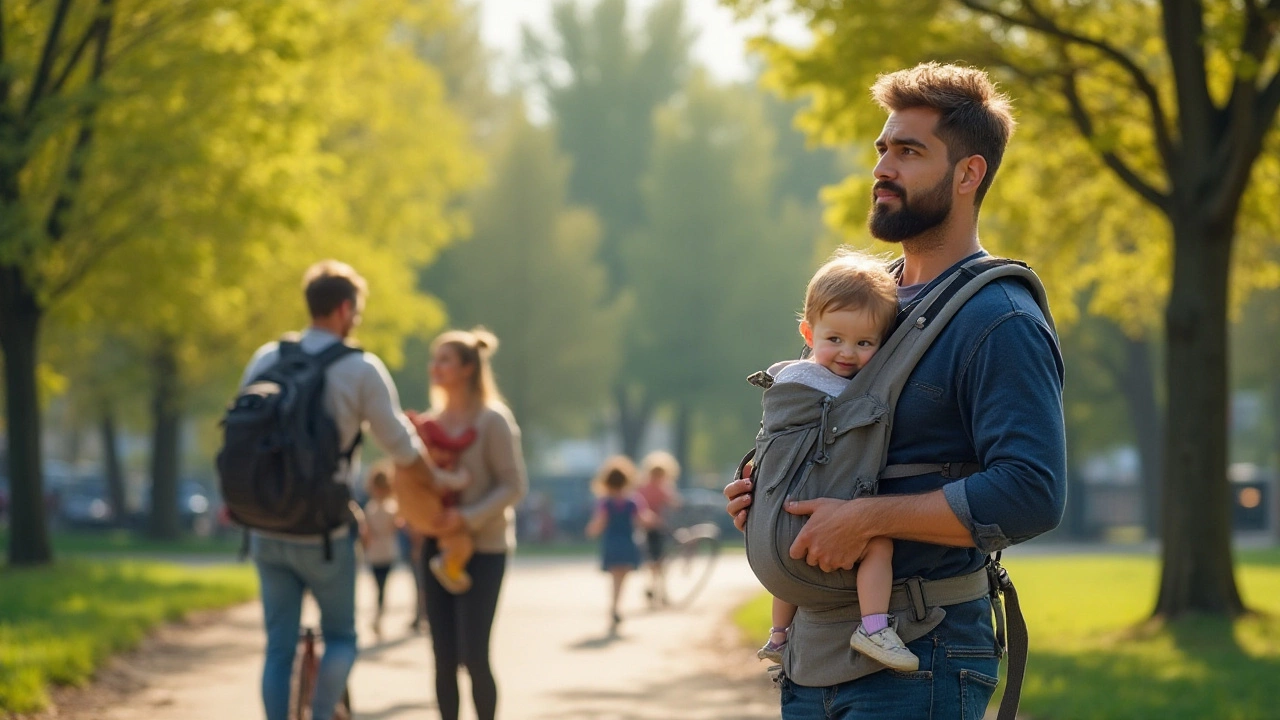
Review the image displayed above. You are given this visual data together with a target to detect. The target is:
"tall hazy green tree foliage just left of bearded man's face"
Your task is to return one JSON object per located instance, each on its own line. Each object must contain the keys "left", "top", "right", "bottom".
{"left": 623, "top": 74, "right": 818, "bottom": 466}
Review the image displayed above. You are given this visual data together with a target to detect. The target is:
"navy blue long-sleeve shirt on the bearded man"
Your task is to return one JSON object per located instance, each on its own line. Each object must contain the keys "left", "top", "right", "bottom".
{"left": 879, "top": 249, "right": 1066, "bottom": 579}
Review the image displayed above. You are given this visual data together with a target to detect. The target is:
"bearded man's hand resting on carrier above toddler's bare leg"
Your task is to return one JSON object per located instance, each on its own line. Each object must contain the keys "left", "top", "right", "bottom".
{"left": 783, "top": 491, "right": 870, "bottom": 573}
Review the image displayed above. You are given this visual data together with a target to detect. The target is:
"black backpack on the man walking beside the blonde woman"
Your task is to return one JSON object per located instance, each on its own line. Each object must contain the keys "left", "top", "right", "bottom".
{"left": 218, "top": 340, "right": 361, "bottom": 559}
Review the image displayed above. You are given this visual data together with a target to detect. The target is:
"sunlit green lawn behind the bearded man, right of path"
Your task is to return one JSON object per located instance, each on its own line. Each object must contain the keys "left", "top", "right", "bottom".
{"left": 735, "top": 550, "right": 1280, "bottom": 720}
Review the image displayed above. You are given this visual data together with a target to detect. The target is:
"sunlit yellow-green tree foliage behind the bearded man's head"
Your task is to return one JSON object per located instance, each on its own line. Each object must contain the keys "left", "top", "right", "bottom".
{"left": 724, "top": 0, "right": 1280, "bottom": 325}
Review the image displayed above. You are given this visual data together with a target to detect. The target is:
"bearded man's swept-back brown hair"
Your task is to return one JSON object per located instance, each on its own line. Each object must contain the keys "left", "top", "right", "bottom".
{"left": 872, "top": 63, "right": 1016, "bottom": 206}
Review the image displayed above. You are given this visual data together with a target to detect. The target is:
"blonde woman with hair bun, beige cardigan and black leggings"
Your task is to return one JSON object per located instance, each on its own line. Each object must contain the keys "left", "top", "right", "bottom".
{"left": 402, "top": 328, "right": 529, "bottom": 720}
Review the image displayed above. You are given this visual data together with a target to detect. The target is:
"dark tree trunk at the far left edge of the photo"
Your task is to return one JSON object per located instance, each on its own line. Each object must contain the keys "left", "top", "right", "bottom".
{"left": 0, "top": 265, "right": 54, "bottom": 566}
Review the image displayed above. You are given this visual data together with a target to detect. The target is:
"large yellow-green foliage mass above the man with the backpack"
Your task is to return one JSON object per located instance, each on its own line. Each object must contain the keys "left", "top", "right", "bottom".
{"left": 41, "top": 0, "right": 480, "bottom": 450}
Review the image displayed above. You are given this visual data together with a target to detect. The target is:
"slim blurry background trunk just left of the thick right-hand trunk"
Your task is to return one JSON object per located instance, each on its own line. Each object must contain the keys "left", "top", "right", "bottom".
{"left": 1119, "top": 336, "right": 1164, "bottom": 538}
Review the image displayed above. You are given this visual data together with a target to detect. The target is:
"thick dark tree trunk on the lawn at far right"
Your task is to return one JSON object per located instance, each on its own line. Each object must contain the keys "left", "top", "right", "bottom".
{"left": 1155, "top": 213, "right": 1244, "bottom": 619}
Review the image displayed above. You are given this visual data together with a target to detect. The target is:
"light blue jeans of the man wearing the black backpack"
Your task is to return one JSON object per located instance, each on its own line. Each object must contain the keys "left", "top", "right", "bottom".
{"left": 251, "top": 534, "right": 356, "bottom": 720}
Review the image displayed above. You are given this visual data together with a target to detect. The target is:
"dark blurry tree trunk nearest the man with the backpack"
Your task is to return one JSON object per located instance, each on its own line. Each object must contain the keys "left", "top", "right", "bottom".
{"left": 147, "top": 343, "right": 182, "bottom": 539}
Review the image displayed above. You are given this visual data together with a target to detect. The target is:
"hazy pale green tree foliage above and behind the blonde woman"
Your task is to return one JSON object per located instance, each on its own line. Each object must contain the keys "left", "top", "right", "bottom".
{"left": 427, "top": 117, "right": 626, "bottom": 433}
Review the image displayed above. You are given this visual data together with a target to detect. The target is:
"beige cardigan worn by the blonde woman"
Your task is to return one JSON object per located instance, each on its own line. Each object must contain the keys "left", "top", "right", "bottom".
{"left": 445, "top": 404, "right": 529, "bottom": 552}
